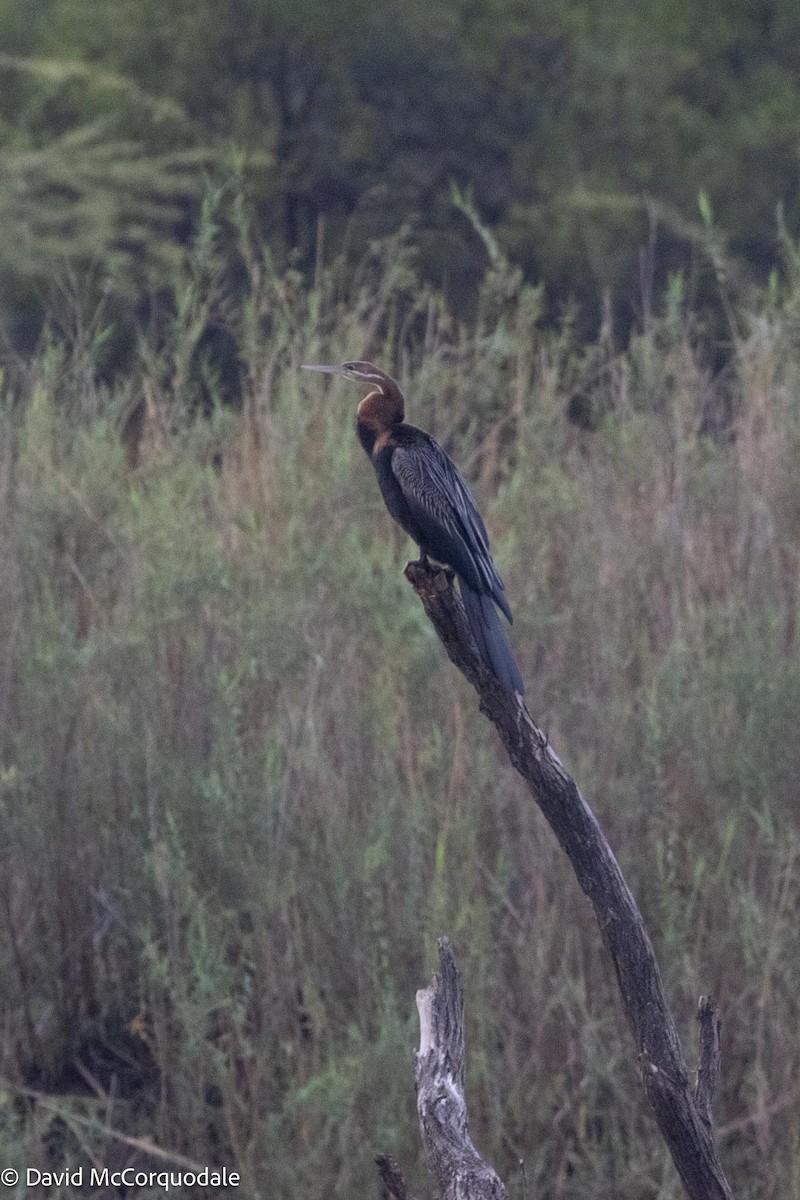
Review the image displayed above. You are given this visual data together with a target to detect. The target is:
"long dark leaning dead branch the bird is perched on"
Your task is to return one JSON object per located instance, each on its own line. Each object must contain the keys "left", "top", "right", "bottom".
{"left": 405, "top": 563, "right": 733, "bottom": 1200}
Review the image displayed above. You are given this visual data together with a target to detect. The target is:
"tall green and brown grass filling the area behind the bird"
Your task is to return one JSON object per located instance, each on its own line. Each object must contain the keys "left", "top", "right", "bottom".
{"left": 0, "top": 224, "right": 800, "bottom": 1200}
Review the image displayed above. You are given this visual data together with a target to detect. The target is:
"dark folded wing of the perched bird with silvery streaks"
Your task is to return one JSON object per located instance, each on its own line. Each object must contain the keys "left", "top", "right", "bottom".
{"left": 391, "top": 434, "right": 511, "bottom": 620}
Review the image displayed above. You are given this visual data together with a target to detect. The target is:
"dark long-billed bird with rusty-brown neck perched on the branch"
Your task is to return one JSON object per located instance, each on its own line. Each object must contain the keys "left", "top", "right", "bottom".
{"left": 303, "top": 362, "right": 525, "bottom": 696}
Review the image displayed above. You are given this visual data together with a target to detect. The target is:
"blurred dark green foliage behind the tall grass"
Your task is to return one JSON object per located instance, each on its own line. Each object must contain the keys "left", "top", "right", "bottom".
{"left": 0, "top": 0, "right": 800, "bottom": 344}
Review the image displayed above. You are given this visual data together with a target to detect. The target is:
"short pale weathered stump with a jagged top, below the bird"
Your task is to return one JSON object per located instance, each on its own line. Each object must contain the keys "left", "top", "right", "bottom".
{"left": 416, "top": 937, "right": 506, "bottom": 1200}
